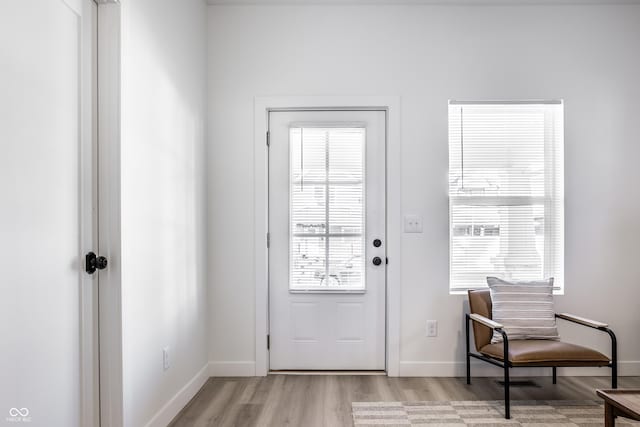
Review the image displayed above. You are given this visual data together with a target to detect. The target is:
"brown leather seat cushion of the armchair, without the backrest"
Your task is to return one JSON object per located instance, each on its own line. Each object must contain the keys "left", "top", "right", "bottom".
{"left": 480, "top": 340, "right": 610, "bottom": 366}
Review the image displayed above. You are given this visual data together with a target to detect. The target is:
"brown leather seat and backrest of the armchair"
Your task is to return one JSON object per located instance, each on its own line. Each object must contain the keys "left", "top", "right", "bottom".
{"left": 469, "top": 289, "right": 611, "bottom": 366}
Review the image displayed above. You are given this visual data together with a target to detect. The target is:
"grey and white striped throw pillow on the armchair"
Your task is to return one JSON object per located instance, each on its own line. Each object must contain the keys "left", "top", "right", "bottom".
{"left": 487, "top": 277, "right": 560, "bottom": 343}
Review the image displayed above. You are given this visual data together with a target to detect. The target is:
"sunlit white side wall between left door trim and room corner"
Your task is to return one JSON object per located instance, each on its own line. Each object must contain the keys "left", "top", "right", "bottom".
{"left": 121, "top": 0, "right": 207, "bottom": 427}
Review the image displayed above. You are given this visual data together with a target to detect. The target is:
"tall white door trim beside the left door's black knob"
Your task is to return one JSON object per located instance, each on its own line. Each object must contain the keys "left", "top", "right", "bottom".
{"left": 97, "top": 2, "right": 124, "bottom": 427}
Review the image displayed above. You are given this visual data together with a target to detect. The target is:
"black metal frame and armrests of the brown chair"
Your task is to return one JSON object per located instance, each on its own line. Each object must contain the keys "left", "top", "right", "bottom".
{"left": 465, "top": 313, "right": 618, "bottom": 419}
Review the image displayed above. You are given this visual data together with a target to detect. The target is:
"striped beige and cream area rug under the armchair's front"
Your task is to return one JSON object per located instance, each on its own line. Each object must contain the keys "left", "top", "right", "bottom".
{"left": 351, "top": 400, "right": 640, "bottom": 427}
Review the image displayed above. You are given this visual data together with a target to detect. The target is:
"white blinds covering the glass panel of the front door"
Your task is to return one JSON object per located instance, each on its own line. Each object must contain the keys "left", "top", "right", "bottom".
{"left": 289, "top": 127, "right": 365, "bottom": 290}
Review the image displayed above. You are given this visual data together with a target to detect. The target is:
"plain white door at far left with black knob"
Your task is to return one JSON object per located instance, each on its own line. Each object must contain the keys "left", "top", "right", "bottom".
{"left": 0, "top": 0, "right": 96, "bottom": 427}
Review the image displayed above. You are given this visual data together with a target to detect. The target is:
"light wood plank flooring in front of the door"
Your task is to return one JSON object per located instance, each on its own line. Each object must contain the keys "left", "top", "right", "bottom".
{"left": 166, "top": 375, "right": 640, "bottom": 427}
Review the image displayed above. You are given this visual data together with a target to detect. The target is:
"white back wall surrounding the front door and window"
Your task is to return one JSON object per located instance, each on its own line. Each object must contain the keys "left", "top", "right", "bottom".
{"left": 208, "top": 5, "right": 640, "bottom": 375}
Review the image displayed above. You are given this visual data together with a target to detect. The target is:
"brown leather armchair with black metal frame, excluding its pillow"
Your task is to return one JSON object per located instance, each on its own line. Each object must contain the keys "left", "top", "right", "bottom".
{"left": 466, "top": 289, "right": 618, "bottom": 419}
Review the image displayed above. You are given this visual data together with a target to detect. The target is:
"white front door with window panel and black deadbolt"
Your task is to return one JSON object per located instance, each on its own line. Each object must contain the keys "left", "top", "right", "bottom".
{"left": 269, "top": 111, "right": 386, "bottom": 370}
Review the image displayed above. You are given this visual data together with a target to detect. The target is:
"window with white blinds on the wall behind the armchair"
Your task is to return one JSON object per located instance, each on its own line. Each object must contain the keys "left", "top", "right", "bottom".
{"left": 449, "top": 101, "right": 564, "bottom": 292}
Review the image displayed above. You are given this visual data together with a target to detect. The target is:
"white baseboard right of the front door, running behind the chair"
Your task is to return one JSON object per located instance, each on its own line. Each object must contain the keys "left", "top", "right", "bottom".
{"left": 399, "top": 360, "right": 640, "bottom": 377}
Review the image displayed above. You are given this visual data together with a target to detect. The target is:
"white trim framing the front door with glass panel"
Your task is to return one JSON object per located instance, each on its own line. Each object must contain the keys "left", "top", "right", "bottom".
{"left": 254, "top": 96, "right": 402, "bottom": 377}
